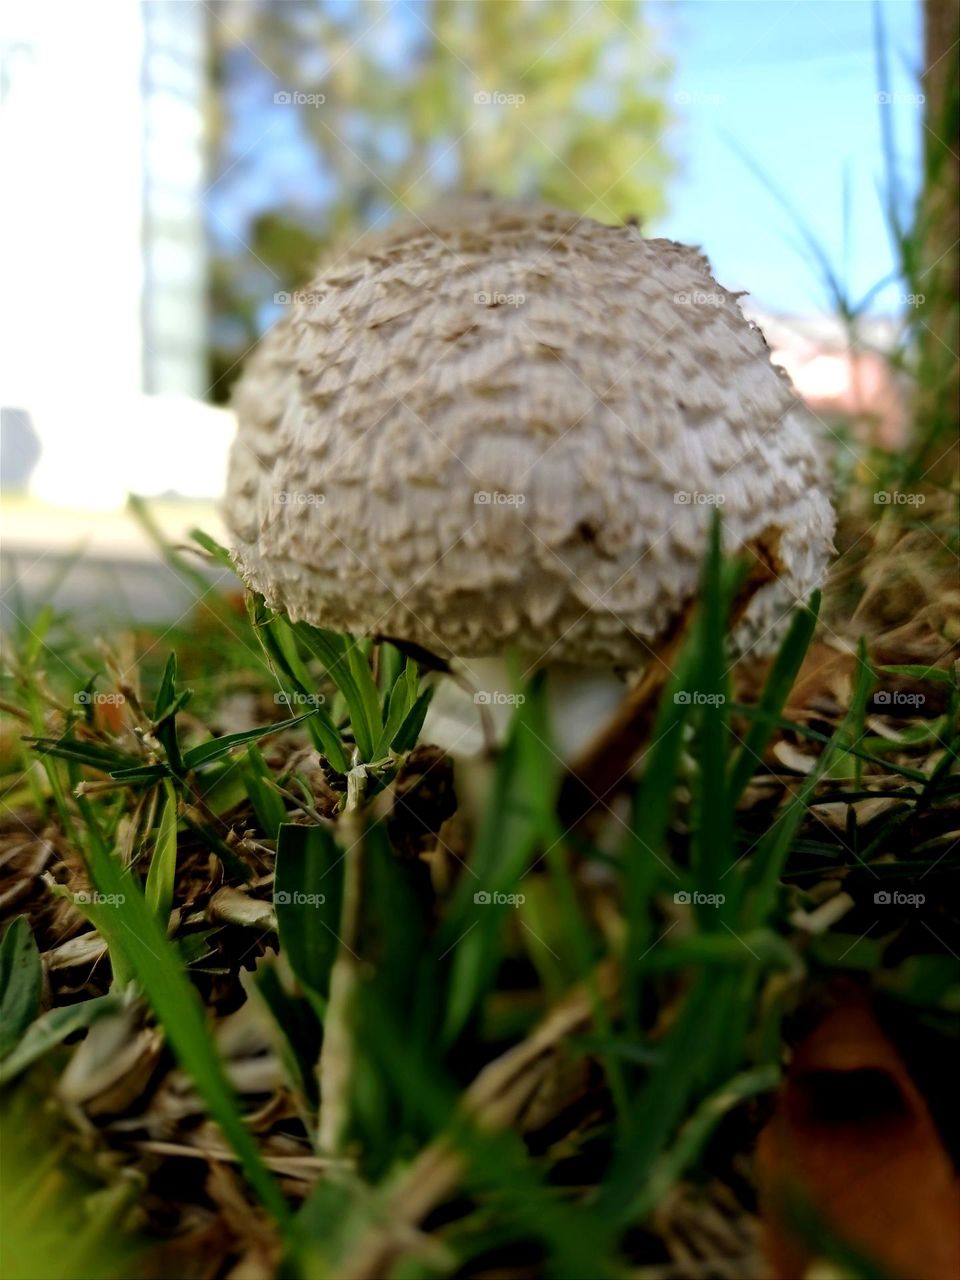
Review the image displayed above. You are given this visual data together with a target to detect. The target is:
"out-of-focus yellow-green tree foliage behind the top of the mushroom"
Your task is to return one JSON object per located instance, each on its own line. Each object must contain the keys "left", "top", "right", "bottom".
{"left": 209, "top": 0, "right": 669, "bottom": 399}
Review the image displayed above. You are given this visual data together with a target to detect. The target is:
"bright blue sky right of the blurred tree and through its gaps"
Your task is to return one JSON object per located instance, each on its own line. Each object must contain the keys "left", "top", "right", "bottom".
{"left": 210, "top": 0, "right": 922, "bottom": 320}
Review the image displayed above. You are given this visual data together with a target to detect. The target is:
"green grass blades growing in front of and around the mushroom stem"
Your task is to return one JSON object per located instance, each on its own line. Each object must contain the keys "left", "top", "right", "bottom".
{"left": 0, "top": 512, "right": 960, "bottom": 1277}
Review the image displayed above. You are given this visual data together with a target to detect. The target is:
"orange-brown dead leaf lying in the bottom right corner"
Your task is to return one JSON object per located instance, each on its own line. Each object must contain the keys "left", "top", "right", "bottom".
{"left": 756, "top": 988, "right": 960, "bottom": 1280}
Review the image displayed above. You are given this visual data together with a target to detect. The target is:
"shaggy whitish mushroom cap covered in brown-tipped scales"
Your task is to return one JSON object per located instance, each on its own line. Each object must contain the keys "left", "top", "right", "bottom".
{"left": 225, "top": 201, "right": 833, "bottom": 666}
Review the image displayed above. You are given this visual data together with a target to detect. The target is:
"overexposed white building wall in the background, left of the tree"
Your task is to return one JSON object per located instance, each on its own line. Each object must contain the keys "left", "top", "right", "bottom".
{"left": 0, "top": 0, "right": 216, "bottom": 507}
